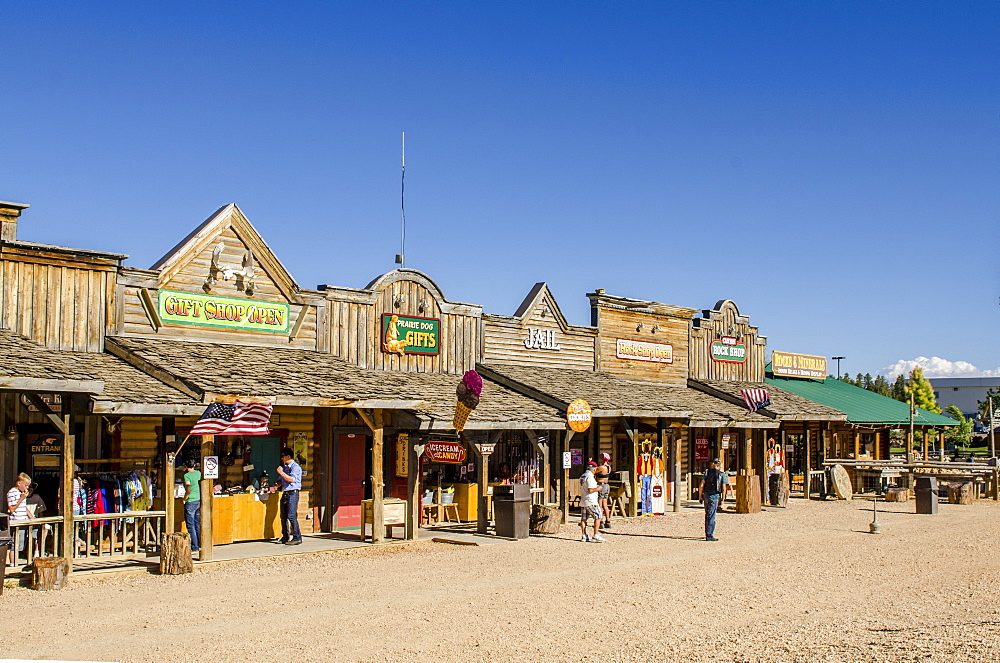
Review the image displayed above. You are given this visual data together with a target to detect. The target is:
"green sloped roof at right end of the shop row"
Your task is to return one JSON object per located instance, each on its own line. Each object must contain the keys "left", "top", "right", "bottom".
{"left": 766, "top": 375, "right": 958, "bottom": 426}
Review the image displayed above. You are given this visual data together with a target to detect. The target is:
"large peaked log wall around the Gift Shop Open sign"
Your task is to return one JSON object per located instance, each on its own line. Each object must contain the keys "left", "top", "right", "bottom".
{"left": 115, "top": 205, "right": 325, "bottom": 350}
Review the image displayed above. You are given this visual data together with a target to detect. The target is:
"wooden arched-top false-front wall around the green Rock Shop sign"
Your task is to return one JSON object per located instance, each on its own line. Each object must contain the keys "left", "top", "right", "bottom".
{"left": 690, "top": 300, "right": 767, "bottom": 382}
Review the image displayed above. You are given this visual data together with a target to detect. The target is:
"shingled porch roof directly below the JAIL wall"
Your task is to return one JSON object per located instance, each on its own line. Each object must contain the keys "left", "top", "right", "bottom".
{"left": 477, "top": 364, "right": 778, "bottom": 428}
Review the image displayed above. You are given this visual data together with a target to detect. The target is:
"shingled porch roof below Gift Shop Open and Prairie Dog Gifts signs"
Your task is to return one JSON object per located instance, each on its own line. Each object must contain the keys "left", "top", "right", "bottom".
{"left": 107, "top": 338, "right": 566, "bottom": 430}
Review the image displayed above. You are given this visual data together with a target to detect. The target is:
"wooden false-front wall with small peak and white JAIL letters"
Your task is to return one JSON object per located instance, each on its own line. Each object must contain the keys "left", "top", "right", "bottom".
{"left": 483, "top": 283, "right": 597, "bottom": 371}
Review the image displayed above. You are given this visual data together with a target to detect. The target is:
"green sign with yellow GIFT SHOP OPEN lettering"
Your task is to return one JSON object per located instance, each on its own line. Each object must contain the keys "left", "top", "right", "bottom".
{"left": 158, "top": 290, "right": 291, "bottom": 334}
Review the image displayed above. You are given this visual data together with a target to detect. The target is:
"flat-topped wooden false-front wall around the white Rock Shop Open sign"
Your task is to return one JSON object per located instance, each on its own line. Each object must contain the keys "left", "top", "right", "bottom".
{"left": 587, "top": 290, "right": 697, "bottom": 386}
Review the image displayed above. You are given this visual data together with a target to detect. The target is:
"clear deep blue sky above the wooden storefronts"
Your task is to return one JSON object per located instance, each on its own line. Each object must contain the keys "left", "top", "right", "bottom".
{"left": 0, "top": 1, "right": 1000, "bottom": 374}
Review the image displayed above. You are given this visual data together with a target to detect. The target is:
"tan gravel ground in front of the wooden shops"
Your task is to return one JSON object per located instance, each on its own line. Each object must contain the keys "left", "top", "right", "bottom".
{"left": 0, "top": 501, "right": 1000, "bottom": 663}
